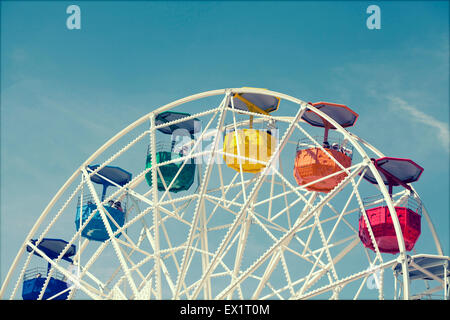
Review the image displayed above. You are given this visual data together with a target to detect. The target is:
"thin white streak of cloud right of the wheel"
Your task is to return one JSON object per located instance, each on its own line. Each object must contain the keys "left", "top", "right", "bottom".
{"left": 389, "top": 97, "right": 450, "bottom": 152}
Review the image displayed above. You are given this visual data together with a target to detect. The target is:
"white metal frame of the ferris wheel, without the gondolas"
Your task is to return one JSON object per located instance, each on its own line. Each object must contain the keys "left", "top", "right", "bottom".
{"left": 0, "top": 88, "right": 443, "bottom": 299}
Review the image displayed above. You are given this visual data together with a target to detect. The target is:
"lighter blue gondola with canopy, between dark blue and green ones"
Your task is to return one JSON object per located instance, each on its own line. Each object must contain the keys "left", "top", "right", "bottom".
{"left": 75, "top": 165, "right": 131, "bottom": 241}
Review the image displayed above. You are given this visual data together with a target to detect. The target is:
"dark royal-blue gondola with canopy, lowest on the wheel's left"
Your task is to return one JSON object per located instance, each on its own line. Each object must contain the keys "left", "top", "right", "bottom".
{"left": 22, "top": 238, "right": 76, "bottom": 300}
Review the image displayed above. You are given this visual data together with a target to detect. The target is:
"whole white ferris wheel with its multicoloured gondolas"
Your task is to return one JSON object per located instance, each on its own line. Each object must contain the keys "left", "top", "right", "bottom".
{"left": 0, "top": 87, "right": 449, "bottom": 300}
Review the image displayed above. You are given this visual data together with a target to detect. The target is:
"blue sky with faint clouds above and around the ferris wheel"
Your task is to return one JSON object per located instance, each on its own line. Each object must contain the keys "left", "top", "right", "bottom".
{"left": 0, "top": 1, "right": 450, "bottom": 298}
